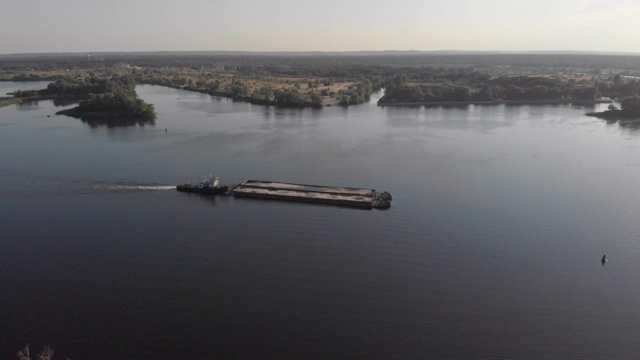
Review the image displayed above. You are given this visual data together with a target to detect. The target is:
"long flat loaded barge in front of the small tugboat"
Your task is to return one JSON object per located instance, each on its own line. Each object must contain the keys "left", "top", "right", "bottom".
{"left": 230, "top": 180, "right": 391, "bottom": 209}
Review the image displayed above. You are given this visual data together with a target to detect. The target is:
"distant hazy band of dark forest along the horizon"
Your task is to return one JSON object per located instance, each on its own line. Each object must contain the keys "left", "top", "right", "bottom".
{"left": 6, "top": 52, "right": 640, "bottom": 76}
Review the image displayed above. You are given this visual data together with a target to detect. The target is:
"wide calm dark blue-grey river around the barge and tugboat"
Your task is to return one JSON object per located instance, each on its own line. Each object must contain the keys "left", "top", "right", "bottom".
{"left": 0, "top": 83, "right": 640, "bottom": 359}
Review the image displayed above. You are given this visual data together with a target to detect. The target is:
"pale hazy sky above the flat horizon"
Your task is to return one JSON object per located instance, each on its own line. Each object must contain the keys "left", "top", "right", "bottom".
{"left": 0, "top": 0, "right": 640, "bottom": 54}
